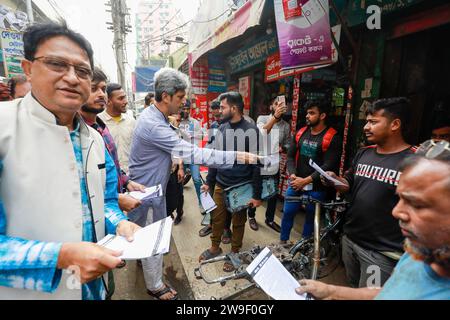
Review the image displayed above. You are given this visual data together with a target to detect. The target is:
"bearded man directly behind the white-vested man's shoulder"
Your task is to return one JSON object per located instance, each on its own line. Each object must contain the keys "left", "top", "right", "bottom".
{"left": 80, "top": 68, "right": 145, "bottom": 212}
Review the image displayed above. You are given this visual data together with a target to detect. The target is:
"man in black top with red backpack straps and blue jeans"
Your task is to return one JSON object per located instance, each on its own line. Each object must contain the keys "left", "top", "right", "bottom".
{"left": 280, "top": 101, "right": 341, "bottom": 243}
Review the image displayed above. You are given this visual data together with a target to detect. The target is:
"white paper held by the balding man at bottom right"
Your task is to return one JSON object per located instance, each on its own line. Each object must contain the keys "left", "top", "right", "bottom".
{"left": 246, "top": 248, "right": 306, "bottom": 300}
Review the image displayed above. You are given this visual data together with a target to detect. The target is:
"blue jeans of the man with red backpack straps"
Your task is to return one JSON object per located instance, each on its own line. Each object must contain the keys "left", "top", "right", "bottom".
{"left": 280, "top": 185, "right": 326, "bottom": 241}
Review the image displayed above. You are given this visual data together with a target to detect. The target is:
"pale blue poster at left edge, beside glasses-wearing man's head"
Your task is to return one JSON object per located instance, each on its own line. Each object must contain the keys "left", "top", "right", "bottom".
{"left": 0, "top": 30, "right": 24, "bottom": 78}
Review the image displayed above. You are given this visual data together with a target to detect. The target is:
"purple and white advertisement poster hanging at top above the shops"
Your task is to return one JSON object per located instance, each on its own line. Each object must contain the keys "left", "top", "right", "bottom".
{"left": 274, "top": 0, "right": 332, "bottom": 70}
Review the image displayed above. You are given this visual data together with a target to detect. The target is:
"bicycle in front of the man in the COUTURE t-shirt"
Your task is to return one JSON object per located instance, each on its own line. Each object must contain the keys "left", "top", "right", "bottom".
{"left": 194, "top": 196, "right": 349, "bottom": 299}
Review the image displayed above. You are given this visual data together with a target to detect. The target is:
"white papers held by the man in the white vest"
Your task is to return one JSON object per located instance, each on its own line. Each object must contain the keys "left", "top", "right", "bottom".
{"left": 97, "top": 217, "right": 173, "bottom": 260}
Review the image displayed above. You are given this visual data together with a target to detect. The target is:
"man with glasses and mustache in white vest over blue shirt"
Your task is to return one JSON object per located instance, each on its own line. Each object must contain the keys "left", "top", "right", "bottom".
{"left": 0, "top": 23, "right": 139, "bottom": 300}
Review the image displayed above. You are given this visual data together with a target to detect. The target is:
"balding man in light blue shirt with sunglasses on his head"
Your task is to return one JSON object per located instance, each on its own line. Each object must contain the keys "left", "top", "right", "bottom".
{"left": 297, "top": 141, "right": 450, "bottom": 300}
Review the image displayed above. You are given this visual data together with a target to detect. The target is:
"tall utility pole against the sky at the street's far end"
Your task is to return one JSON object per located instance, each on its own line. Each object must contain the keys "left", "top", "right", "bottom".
{"left": 106, "top": 0, "right": 131, "bottom": 91}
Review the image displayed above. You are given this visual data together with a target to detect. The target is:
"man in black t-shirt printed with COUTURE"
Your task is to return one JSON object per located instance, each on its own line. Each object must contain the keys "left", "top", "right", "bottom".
{"left": 330, "top": 98, "right": 415, "bottom": 287}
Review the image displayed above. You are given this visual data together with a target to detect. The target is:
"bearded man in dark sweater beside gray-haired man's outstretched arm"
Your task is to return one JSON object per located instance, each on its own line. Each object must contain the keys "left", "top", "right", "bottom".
{"left": 199, "top": 92, "right": 262, "bottom": 272}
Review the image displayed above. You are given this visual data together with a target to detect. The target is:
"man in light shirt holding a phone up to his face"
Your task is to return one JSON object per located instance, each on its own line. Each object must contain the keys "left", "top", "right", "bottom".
{"left": 248, "top": 98, "right": 291, "bottom": 233}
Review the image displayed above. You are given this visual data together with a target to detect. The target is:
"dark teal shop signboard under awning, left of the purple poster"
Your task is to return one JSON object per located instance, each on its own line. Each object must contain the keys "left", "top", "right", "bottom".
{"left": 228, "top": 35, "right": 278, "bottom": 74}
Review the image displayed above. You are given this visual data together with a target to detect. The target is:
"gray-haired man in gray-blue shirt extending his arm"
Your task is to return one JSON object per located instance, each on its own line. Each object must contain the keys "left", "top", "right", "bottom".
{"left": 129, "top": 68, "right": 258, "bottom": 300}
